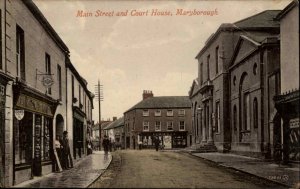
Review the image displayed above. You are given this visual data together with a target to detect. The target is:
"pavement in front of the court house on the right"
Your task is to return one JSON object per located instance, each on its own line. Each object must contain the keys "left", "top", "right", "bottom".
{"left": 192, "top": 152, "right": 300, "bottom": 188}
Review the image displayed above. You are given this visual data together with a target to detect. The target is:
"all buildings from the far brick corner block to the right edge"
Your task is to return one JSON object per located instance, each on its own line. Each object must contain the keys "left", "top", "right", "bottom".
{"left": 118, "top": 1, "right": 300, "bottom": 164}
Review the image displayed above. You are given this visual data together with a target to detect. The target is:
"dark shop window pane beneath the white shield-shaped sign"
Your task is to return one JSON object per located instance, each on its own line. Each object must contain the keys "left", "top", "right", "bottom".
{"left": 15, "top": 112, "right": 33, "bottom": 165}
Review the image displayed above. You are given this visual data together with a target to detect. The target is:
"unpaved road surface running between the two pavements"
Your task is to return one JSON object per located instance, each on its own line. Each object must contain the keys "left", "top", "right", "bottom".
{"left": 90, "top": 150, "right": 282, "bottom": 188}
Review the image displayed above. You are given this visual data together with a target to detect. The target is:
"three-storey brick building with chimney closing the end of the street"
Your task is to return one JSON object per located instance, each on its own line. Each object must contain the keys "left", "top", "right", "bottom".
{"left": 124, "top": 91, "right": 192, "bottom": 149}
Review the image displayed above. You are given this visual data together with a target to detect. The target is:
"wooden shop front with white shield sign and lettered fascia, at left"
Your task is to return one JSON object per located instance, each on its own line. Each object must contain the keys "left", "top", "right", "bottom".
{"left": 13, "top": 86, "right": 57, "bottom": 184}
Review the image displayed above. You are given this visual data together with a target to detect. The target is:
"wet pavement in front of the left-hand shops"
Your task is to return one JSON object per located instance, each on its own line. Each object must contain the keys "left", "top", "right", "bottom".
{"left": 14, "top": 151, "right": 112, "bottom": 188}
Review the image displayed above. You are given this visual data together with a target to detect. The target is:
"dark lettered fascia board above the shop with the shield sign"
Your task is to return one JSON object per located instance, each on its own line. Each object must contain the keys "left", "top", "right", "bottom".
{"left": 16, "top": 94, "right": 53, "bottom": 117}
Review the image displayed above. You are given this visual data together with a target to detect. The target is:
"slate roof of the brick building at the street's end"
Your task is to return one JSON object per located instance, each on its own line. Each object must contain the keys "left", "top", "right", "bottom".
{"left": 125, "top": 96, "right": 192, "bottom": 113}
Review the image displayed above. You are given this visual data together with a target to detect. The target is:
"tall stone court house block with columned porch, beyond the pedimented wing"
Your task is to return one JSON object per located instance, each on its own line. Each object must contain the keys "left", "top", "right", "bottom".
{"left": 189, "top": 10, "right": 279, "bottom": 154}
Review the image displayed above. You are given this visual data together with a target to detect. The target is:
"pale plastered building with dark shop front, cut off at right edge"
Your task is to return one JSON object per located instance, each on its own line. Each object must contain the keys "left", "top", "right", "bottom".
{"left": 270, "top": 1, "right": 300, "bottom": 163}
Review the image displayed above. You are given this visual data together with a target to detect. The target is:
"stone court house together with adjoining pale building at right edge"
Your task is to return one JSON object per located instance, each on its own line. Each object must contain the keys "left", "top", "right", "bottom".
{"left": 189, "top": 1, "right": 299, "bottom": 161}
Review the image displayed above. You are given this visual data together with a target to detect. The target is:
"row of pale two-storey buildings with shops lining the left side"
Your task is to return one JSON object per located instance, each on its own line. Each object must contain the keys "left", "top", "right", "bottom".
{"left": 0, "top": 0, "right": 94, "bottom": 187}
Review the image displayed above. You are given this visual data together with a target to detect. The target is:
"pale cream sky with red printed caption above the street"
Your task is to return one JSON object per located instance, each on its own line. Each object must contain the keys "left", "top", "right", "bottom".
{"left": 33, "top": 0, "right": 290, "bottom": 122}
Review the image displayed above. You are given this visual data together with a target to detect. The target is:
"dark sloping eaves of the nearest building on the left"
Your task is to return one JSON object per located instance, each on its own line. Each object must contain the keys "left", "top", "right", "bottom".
{"left": 22, "top": 0, "right": 70, "bottom": 54}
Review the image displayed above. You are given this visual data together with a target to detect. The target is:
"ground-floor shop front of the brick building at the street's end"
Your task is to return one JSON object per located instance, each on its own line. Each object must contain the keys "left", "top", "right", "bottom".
{"left": 138, "top": 131, "right": 187, "bottom": 149}
